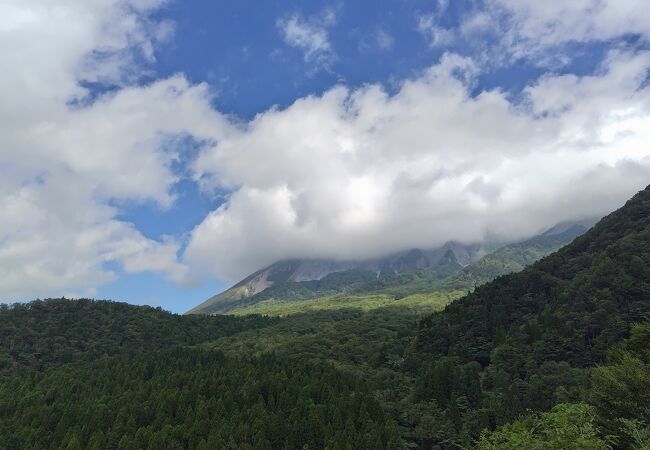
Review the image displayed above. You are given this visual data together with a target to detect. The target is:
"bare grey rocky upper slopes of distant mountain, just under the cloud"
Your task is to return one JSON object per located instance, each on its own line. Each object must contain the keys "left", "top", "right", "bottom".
{"left": 188, "top": 242, "right": 489, "bottom": 314}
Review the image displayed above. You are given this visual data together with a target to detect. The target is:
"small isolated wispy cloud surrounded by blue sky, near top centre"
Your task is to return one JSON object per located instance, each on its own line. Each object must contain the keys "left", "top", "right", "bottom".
{"left": 276, "top": 9, "right": 336, "bottom": 67}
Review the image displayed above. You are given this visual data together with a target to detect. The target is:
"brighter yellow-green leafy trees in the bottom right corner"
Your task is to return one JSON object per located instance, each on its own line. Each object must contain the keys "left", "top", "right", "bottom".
{"left": 478, "top": 322, "right": 650, "bottom": 450}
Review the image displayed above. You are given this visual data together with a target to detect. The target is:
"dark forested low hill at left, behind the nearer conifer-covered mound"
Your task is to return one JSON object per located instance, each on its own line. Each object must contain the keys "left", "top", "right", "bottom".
{"left": 0, "top": 299, "right": 277, "bottom": 378}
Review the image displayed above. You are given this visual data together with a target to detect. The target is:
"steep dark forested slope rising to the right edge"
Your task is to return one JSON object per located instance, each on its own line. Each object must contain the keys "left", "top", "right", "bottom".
{"left": 402, "top": 183, "right": 650, "bottom": 448}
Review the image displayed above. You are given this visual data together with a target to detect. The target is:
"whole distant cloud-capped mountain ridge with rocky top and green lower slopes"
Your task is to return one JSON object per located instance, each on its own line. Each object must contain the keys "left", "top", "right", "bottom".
{"left": 188, "top": 220, "right": 595, "bottom": 314}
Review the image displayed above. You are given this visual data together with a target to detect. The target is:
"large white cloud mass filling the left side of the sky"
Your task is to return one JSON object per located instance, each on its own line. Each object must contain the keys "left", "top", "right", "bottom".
{"left": 0, "top": 0, "right": 229, "bottom": 300}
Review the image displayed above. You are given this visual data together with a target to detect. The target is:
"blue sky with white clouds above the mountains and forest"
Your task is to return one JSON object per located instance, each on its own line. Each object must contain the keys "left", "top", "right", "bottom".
{"left": 0, "top": 0, "right": 650, "bottom": 312}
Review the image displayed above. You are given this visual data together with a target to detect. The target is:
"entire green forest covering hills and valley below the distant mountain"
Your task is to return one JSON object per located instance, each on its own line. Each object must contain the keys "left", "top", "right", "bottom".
{"left": 0, "top": 188, "right": 650, "bottom": 449}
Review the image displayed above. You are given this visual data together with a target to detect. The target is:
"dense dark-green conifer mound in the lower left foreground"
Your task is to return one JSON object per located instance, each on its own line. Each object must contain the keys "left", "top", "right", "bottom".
{"left": 0, "top": 348, "right": 399, "bottom": 449}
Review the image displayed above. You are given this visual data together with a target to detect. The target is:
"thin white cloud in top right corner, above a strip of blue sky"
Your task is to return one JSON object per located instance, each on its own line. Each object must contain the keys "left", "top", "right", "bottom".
{"left": 466, "top": 0, "right": 650, "bottom": 66}
